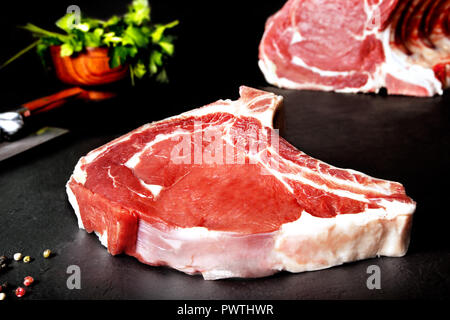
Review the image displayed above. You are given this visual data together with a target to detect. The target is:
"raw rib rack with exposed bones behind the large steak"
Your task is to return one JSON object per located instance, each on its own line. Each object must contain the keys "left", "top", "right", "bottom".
{"left": 259, "top": 0, "right": 450, "bottom": 96}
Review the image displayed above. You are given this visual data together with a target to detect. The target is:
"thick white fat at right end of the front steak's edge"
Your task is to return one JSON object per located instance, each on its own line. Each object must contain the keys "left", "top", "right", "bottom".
{"left": 274, "top": 203, "right": 415, "bottom": 272}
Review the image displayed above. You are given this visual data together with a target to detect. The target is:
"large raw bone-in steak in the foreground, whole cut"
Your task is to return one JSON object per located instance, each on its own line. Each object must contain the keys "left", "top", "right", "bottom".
{"left": 67, "top": 87, "right": 415, "bottom": 279}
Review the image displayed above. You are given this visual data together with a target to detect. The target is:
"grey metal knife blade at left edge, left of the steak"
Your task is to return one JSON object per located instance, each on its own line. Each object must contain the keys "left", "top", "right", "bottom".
{"left": 0, "top": 127, "right": 69, "bottom": 161}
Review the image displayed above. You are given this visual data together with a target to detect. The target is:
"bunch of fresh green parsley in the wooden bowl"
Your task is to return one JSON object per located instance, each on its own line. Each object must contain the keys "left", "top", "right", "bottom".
{"left": 2, "top": 0, "right": 178, "bottom": 84}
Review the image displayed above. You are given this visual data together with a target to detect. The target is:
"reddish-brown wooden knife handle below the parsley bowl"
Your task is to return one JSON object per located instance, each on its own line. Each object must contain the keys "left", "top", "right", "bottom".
{"left": 19, "top": 87, "right": 85, "bottom": 117}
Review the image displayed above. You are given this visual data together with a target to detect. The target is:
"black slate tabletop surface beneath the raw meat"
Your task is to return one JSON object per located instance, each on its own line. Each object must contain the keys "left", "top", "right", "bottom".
{"left": 0, "top": 87, "right": 450, "bottom": 299}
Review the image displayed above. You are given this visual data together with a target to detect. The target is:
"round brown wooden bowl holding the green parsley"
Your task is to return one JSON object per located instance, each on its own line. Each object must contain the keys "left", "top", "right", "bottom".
{"left": 50, "top": 46, "right": 128, "bottom": 86}
